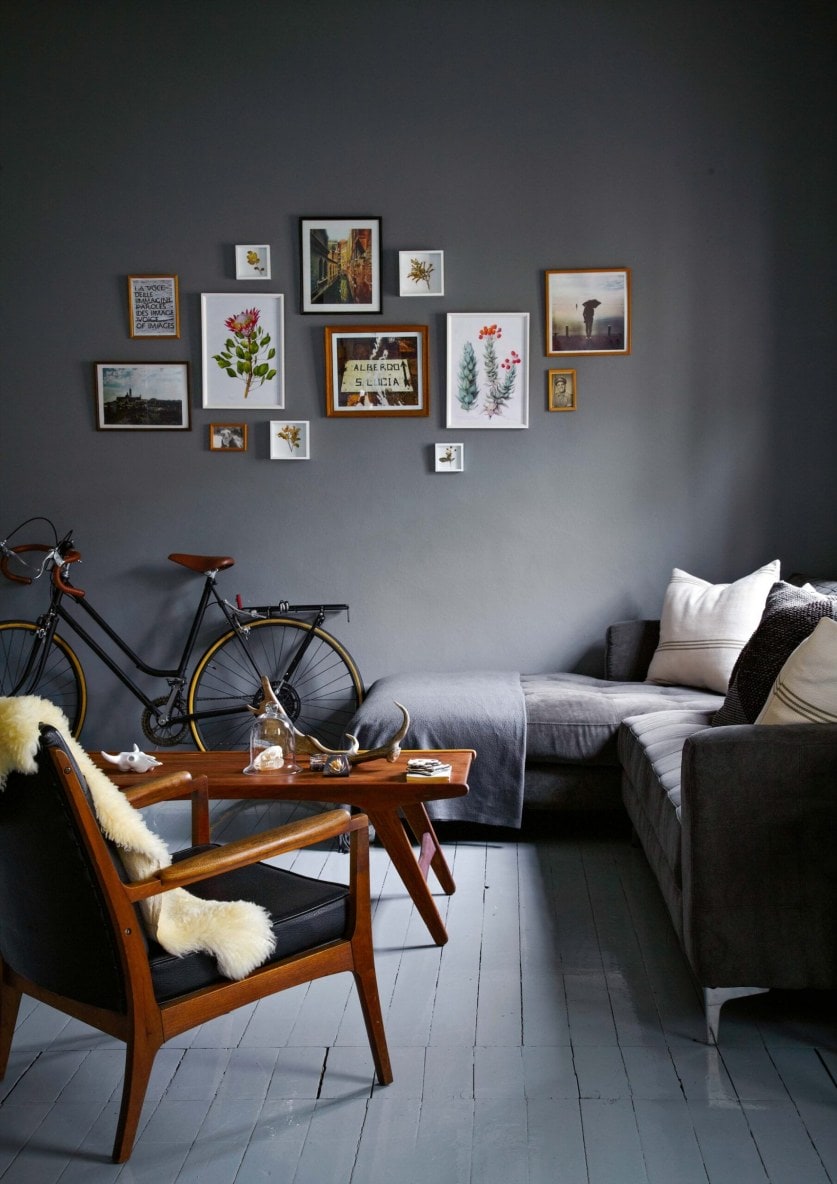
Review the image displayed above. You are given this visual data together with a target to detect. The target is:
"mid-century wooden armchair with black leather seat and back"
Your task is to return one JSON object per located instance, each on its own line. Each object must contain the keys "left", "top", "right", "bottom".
{"left": 0, "top": 727, "right": 392, "bottom": 1163}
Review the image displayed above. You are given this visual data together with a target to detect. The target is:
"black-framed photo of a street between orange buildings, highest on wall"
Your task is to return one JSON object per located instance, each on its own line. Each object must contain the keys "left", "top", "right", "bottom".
{"left": 300, "top": 218, "right": 381, "bottom": 315}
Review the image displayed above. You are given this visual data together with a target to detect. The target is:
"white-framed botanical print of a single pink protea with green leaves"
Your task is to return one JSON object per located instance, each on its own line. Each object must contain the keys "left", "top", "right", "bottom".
{"left": 200, "top": 292, "right": 285, "bottom": 411}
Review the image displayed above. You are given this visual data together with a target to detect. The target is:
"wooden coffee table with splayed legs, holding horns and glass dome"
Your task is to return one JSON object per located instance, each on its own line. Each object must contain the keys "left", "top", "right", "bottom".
{"left": 90, "top": 748, "right": 476, "bottom": 946}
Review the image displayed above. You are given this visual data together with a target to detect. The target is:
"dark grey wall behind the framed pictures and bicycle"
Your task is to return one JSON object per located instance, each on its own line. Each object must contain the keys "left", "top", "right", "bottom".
{"left": 0, "top": 0, "right": 837, "bottom": 745}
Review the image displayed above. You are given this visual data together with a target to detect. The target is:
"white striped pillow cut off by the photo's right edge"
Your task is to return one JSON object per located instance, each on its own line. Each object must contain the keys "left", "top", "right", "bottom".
{"left": 755, "top": 617, "right": 837, "bottom": 723}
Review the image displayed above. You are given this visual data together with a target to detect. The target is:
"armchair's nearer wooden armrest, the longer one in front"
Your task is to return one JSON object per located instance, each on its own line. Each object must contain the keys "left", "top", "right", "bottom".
{"left": 125, "top": 810, "right": 369, "bottom": 901}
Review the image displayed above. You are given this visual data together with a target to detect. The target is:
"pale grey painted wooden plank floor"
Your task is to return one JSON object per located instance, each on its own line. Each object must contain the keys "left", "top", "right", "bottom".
{"left": 0, "top": 803, "right": 837, "bottom": 1184}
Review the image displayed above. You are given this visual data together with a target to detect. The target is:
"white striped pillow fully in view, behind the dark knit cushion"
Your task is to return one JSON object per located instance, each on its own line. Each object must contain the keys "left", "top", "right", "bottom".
{"left": 648, "top": 559, "right": 780, "bottom": 695}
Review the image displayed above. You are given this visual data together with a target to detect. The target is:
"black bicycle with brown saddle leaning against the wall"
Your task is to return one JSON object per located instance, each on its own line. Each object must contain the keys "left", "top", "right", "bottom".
{"left": 0, "top": 517, "right": 363, "bottom": 749}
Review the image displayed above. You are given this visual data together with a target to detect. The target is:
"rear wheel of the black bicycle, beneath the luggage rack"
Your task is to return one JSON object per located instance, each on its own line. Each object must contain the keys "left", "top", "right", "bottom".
{"left": 188, "top": 617, "right": 363, "bottom": 751}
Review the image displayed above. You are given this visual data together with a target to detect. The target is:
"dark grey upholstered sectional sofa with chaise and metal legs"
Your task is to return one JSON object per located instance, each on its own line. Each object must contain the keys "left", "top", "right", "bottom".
{"left": 349, "top": 577, "right": 837, "bottom": 1041}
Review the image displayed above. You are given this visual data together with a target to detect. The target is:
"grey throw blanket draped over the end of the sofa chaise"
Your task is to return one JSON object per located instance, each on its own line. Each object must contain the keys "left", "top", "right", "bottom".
{"left": 347, "top": 670, "right": 526, "bottom": 826}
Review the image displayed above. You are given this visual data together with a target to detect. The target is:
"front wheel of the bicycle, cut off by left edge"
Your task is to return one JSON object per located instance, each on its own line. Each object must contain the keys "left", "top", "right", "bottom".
{"left": 0, "top": 620, "right": 88, "bottom": 736}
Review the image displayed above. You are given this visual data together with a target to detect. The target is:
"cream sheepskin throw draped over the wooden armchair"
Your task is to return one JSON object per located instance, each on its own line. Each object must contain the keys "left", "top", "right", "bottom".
{"left": 0, "top": 695, "right": 276, "bottom": 979}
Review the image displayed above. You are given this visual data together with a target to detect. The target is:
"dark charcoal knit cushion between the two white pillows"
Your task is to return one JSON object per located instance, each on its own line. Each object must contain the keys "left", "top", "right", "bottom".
{"left": 713, "top": 581, "right": 837, "bottom": 726}
